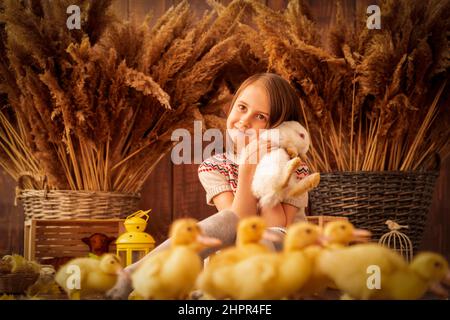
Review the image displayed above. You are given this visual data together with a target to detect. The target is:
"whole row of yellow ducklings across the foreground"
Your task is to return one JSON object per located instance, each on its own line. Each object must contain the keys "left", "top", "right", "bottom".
{"left": 56, "top": 217, "right": 450, "bottom": 300}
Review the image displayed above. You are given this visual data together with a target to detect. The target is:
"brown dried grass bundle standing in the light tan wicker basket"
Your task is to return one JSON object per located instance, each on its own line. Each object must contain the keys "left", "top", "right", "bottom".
{"left": 0, "top": 0, "right": 258, "bottom": 192}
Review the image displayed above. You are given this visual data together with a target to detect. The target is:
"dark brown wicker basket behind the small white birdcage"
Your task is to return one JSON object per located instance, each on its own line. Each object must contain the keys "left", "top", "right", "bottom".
{"left": 309, "top": 171, "right": 439, "bottom": 250}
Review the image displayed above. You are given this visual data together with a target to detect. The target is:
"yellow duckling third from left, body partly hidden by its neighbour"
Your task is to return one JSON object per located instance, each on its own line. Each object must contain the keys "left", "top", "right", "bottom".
{"left": 196, "top": 217, "right": 280, "bottom": 299}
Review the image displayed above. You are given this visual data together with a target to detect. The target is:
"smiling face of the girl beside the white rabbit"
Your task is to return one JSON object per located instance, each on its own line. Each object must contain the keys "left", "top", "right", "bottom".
{"left": 227, "top": 83, "right": 270, "bottom": 145}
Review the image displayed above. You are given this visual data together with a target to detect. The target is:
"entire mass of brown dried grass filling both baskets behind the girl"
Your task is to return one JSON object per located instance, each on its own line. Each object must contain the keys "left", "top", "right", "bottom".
{"left": 0, "top": 0, "right": 450, "bottom": 192}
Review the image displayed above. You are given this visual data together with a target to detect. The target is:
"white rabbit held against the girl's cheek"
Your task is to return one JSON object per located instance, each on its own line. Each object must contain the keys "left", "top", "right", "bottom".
{"left": 252, "top": 121, "right": 320, "bottom": 207}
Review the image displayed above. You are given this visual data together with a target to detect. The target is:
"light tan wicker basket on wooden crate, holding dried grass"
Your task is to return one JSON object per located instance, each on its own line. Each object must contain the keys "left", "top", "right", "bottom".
{"left": 17, "top": 190, "right": 140, "bottom": 220}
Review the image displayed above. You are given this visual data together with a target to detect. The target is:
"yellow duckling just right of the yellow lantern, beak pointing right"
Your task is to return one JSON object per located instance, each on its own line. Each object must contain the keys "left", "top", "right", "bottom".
{"left": 131, "top": 219, "right": 220, "bottom": 300}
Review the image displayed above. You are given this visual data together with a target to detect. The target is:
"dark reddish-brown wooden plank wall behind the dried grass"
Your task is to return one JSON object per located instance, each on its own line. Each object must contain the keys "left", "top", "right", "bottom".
{"left": 0, "top": 0, "right": 450, "bottom": 258}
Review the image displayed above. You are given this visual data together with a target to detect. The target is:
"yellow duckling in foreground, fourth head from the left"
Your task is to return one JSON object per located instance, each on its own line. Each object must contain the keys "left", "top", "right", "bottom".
{"left": 223, "top": 222, "right": 320, "bottom": 300}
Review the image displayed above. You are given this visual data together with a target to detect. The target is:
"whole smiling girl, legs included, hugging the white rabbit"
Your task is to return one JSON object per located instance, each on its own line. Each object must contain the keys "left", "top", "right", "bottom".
{"left": 108, "top": 73, "right": 308, "bottom": 299}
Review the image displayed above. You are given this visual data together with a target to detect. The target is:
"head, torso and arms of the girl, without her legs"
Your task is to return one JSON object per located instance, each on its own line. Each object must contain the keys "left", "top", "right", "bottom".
{"left": 198, "top": 73, "right": 308, "bottom": 227}
